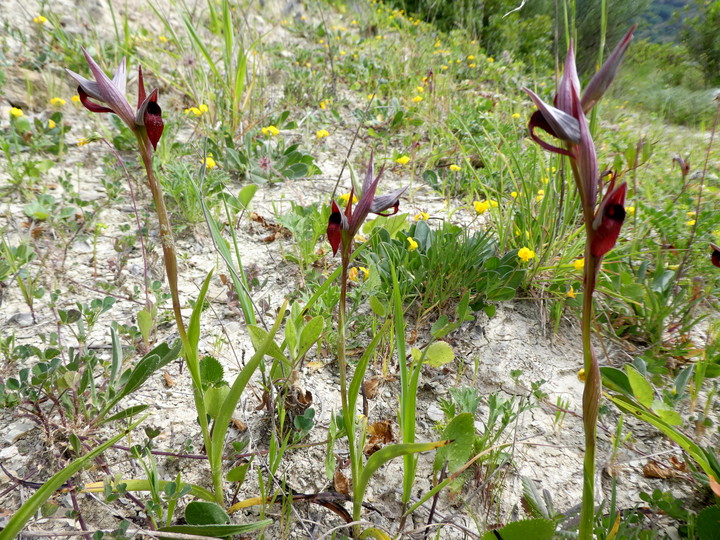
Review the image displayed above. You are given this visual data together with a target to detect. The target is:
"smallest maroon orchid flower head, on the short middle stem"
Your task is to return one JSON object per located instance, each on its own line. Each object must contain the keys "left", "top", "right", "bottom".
{"left": 327, "top": 150, "right": 407, "bottom": 255}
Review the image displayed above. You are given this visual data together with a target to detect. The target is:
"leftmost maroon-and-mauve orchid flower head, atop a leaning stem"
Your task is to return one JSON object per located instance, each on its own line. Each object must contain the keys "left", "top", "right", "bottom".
{"left": 65, "top": 49, "right": 164, "bottom": 150}
